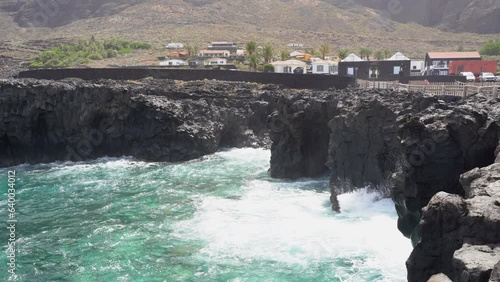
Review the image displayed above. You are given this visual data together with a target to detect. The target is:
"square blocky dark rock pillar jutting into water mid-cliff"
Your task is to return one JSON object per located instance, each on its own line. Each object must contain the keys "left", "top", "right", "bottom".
{"left": 269, "top": 92, "right": 337, "bottom": 179}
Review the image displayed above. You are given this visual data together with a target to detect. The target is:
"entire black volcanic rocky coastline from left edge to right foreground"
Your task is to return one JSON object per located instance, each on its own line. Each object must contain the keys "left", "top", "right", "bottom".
{"left": 0, "top": 79, "right": 500, "bottom": 281}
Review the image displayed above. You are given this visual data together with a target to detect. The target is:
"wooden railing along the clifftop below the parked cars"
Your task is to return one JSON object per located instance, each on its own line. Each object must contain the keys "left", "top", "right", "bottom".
{"left": 358, "top": 80, "right": 500, "bottom": 98}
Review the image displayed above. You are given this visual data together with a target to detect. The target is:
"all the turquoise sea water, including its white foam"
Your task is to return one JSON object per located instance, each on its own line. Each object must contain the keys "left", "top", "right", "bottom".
{"left": 0, "top": 149, "right": 411, "bottom": 282}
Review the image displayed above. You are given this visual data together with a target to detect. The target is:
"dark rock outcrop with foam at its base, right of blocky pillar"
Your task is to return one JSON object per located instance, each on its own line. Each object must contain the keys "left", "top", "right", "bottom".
{"left": 327, "top": 91, "right": 439, "bottom": 193}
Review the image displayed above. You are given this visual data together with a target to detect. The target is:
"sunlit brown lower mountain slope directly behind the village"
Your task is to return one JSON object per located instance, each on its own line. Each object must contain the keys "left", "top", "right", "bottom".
{"left": 0, "top": 0, "right": 498, "bottom": 62}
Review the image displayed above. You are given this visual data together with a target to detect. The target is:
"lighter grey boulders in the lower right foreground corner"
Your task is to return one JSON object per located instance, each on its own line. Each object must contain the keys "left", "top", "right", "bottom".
{"left": 407, "top": 159, "right": 500, "bottom": 281}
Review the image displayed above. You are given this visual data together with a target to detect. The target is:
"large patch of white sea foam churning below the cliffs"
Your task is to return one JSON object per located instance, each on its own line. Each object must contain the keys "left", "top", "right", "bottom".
{"left": 176, "top": 180, "right": 411, "bottom": 281}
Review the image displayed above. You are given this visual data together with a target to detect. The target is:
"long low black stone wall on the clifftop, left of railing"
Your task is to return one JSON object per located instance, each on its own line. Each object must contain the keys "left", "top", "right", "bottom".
{"left": 19, "top": 68, "right": 356, "bottom": 90}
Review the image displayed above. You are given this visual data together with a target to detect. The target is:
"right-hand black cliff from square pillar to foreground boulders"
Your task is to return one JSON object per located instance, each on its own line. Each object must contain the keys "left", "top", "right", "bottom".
{"left": 270, "top": 90, "right": 500, "bottom": 281}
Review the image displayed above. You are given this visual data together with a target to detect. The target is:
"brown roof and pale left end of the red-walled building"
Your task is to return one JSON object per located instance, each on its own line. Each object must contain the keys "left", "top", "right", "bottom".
{"left": 424, "top": 51, "right": 481, "bottom": 75}
